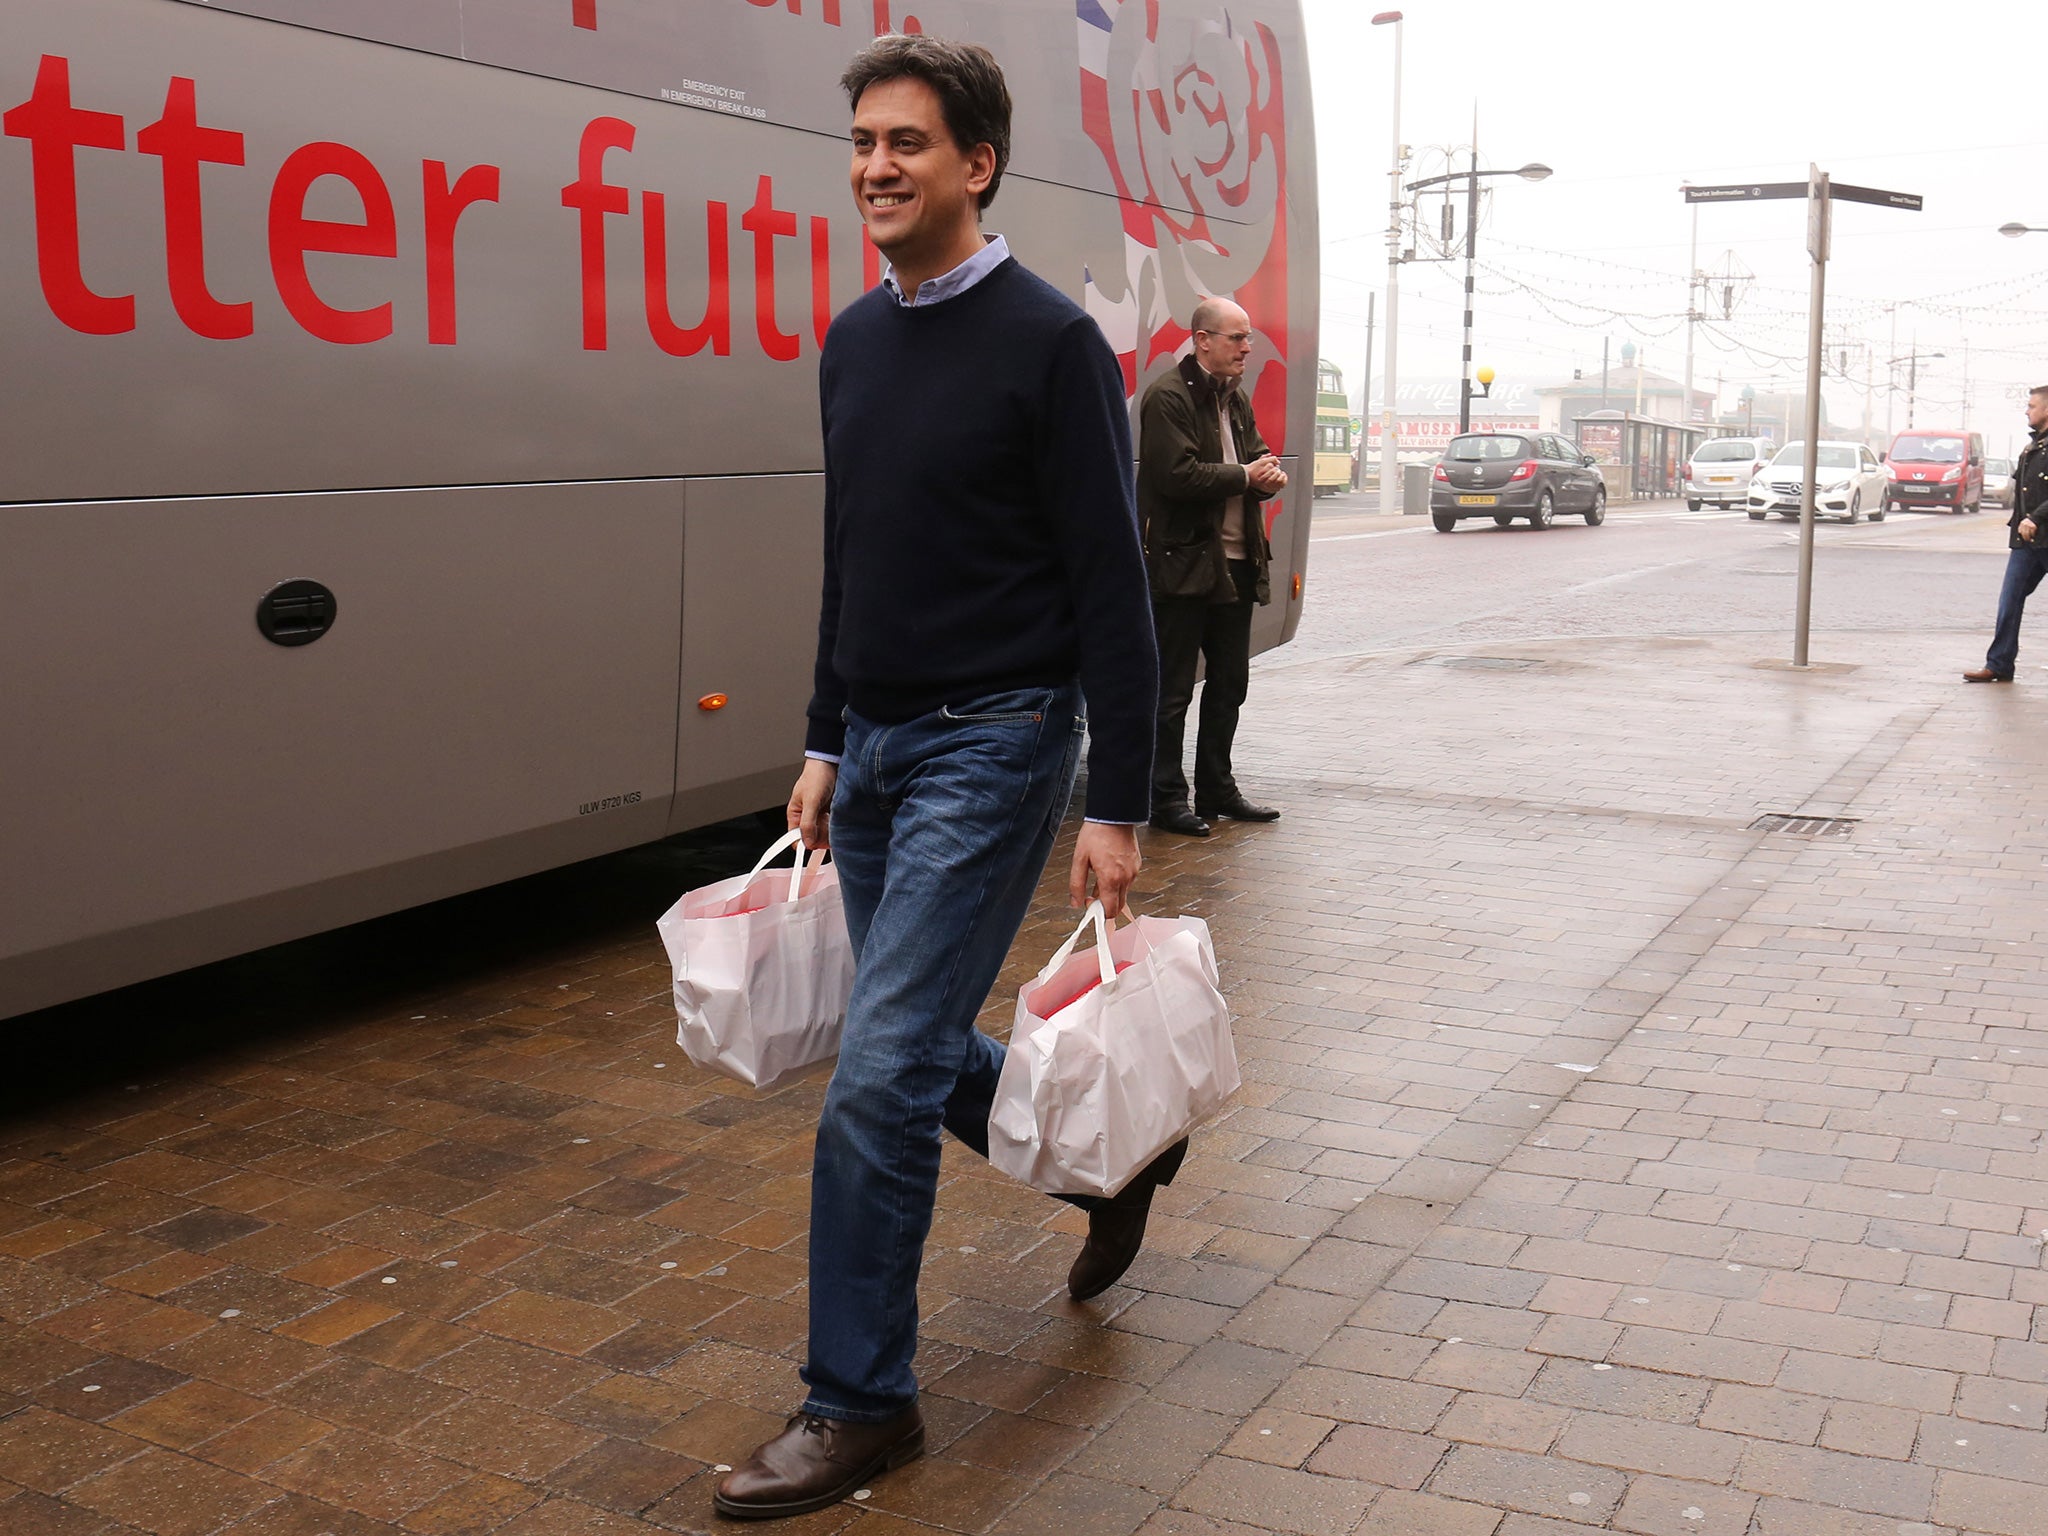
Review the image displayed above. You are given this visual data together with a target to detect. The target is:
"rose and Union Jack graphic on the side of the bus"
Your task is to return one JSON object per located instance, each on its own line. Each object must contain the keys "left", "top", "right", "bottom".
{"left": 1075, "top": 0, "right": 1288, "bottom": 453}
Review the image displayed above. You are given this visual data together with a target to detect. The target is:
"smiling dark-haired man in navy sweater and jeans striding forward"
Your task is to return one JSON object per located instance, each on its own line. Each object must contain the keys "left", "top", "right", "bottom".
{"left": 715, "top": 37, "right": 1186, "bottom": 1518}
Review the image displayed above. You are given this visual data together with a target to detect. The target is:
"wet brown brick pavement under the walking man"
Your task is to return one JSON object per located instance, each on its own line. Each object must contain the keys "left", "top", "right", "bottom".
{"left": 0, "top": 637, "right": 2048, "bottom": 1536}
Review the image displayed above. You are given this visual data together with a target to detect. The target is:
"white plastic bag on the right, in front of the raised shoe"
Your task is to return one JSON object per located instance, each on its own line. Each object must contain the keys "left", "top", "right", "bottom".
{"left": 989, "top": 901, "right": 1239, "bottom": 1194}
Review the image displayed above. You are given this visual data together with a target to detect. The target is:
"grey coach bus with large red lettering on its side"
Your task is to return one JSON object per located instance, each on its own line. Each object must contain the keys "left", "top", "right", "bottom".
{"left": 0, "top": 0, "right": 1317, "bottom": 1016}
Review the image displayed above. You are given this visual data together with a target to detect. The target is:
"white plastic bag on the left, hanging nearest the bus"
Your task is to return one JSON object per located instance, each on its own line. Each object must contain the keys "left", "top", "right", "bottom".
{"left": 657, "top": 831, "right": 854, "bottom": 1087}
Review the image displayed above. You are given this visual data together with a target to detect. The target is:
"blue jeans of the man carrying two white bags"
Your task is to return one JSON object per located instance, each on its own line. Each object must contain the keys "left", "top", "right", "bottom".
{"left": 803, "top": 684, "right": 1085, "bottom": 1421}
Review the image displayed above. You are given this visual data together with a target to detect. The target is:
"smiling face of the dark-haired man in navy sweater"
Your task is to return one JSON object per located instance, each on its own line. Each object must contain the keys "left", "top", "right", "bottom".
{"left": 852, "top": 76, "right": 995, "bottom": 281}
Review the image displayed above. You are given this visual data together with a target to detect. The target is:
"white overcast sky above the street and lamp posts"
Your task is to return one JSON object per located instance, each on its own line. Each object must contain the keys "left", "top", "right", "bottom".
{"left": 1303, "top": 0, "right": 2048, "bottom": 451}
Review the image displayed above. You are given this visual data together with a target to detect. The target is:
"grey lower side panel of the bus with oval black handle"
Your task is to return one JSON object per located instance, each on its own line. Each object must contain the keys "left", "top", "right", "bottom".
{"left": 0, "top": 481, "right": 682, "bottom": 1016}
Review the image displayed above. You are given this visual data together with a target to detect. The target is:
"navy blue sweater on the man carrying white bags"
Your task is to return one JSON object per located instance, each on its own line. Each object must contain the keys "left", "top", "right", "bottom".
{"left": 807, "top": 260, "right": 1159, "bottom": 821}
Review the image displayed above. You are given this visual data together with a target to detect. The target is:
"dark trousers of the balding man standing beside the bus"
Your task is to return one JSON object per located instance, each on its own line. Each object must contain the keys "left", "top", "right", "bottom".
{"left": 1153, "top": 559, "right": 1257, "bottom": 815}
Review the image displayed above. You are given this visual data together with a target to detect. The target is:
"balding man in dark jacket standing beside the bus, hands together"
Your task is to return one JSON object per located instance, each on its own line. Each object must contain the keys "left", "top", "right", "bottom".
{"left": 1139, "top": 299, "right": 1286, "bottom": 838}
